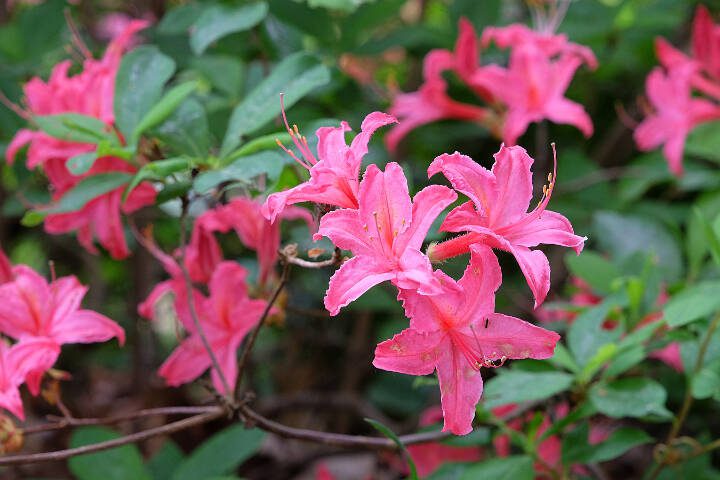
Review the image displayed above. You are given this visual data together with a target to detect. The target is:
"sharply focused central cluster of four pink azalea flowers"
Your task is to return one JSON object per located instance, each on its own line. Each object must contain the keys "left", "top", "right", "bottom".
{"left": 263, "top": 112, "right": 585, "bottom": 435}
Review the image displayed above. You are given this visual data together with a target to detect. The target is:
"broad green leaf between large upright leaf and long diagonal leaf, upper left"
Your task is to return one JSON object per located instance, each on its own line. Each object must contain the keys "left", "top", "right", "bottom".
{"left": 152, "top": 97, "right": 210, "bottom": 157}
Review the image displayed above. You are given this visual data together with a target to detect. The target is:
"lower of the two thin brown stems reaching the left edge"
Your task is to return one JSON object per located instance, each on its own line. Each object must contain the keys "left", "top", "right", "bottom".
{"left": 0, "top": 407, "right": 225, "bottom": 467}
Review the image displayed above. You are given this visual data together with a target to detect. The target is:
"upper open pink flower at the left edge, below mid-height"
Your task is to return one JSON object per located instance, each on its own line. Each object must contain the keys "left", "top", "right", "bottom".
{"left": 0, "top": 265, "right": 125, "bottom": 394}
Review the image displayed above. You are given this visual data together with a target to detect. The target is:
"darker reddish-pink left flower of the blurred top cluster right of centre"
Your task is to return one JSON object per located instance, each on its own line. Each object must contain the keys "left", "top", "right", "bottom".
{"left": 385, "top": 41, "right": 489, "bottom": 153}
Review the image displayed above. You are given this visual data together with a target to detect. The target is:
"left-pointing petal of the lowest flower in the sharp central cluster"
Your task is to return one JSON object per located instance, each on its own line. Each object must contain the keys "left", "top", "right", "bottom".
{"left": 373, "top": 328, "right": 444, "bottom": 375}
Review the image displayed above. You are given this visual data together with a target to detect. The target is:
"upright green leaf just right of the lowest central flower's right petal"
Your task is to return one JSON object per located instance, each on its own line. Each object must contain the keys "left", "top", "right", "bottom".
{"left": 567, "top": 296, "right": 621, "bottom": 368}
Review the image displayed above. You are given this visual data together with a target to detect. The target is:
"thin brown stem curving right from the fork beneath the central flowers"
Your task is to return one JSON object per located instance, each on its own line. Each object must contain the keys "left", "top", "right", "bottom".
{"left": 238, "top": 405, "right": 450, "bottom": 450}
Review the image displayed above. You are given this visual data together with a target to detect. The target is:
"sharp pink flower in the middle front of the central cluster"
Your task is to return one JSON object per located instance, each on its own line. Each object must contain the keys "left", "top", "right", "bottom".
{"left": 314, "top": 162, "right": 457, "bottom": 315}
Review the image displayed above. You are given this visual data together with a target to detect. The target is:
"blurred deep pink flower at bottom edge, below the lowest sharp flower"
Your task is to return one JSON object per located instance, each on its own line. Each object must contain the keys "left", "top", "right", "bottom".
{"left": 408, "top": 406, "right": 483, "bottom": 478}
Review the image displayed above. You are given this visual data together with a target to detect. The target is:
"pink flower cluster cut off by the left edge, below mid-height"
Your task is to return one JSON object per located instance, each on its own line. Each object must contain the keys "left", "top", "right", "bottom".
{"left": 0, "top": 249, "right": 125, "bottom": 419}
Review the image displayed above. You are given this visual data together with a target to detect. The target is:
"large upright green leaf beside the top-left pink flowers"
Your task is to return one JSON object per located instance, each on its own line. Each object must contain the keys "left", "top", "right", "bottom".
{"left": 115, "top": 45, "right": 175, "bottom": 138}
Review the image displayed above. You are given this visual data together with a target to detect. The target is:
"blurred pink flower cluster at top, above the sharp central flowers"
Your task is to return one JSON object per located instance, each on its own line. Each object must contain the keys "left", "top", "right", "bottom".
{"left": 387, "top": 19, "right": 597, "bottom": 151}
